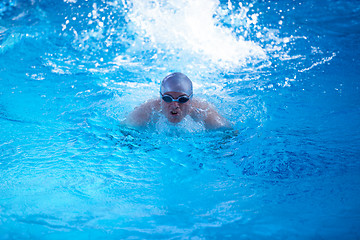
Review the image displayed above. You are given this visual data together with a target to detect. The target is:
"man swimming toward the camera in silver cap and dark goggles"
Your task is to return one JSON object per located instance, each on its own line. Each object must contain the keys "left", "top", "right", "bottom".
{"left": 126, "top": 72, "right": 230, "bottom": 129}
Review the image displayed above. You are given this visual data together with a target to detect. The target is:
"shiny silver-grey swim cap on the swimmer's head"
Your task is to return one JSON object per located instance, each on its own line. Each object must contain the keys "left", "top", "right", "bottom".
{"left": 160, "top": 72, "right": 193, "bottom": 96}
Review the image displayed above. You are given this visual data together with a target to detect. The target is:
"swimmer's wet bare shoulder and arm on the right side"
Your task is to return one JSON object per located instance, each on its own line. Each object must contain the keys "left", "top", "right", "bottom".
{"left": 190, "top": 101, "right": 231, "bottom": 130}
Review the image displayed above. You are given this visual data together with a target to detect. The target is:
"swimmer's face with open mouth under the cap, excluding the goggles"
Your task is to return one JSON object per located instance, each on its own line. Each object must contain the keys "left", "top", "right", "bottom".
{"left": 161, "top": 92, "right": 191, "bottom": 123}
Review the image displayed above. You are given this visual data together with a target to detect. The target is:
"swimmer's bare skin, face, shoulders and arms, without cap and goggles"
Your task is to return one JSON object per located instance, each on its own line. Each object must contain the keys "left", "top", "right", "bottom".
{"left": 126, "top": 92, "right": 230, "bottom": 130}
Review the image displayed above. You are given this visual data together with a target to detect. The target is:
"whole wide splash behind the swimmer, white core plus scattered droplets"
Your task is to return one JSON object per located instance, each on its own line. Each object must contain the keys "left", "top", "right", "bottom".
{"left": 54, "top": 0, "right": 281, "bottom": 72}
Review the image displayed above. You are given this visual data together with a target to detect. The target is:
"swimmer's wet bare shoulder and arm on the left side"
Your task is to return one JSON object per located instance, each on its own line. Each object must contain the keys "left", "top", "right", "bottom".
{"left": 125, "top": 99, "right": 159, "bottom": 127}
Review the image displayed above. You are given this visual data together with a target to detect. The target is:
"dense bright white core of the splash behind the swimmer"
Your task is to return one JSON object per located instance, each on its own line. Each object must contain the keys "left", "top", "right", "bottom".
{"left": 124, "top": 0, "right": 266, "bottom": 69}
